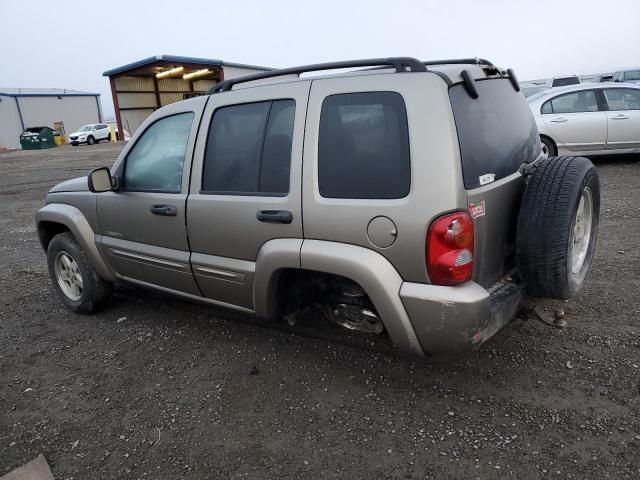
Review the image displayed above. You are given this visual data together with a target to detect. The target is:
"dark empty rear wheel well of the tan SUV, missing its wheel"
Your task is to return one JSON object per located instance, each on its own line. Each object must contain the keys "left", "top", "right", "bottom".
{"left": 276, "top": 268, "right": 370, "bottom": 316}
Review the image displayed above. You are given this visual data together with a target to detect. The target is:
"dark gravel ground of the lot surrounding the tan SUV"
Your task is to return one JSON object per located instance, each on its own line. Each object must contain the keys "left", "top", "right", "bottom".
{"left": 0, "top": 145, "right": 640, "bottom": 480}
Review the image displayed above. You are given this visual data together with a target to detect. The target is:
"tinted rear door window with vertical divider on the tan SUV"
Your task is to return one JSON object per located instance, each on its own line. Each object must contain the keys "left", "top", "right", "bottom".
{"left": 202, "top": 100, "right": 295, "bottom": 195}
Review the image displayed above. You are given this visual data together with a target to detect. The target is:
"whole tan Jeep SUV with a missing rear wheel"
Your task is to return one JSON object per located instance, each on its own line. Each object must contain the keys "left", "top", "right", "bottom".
{"left": 36, "top": 58, "right": 600, "bottom": 355}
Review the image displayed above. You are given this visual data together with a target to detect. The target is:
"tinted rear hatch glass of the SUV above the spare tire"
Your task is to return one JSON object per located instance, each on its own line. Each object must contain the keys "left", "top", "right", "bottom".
{"left": 449, "top": 79, "right": 540, "bottom": 189}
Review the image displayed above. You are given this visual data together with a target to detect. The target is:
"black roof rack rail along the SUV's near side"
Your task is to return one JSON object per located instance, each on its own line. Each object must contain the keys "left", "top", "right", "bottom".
{"left": 207, "top": 57, "right": 427, "bottom": 95}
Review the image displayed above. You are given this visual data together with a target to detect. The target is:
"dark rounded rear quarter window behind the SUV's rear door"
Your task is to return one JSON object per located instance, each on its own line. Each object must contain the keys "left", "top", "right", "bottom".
{"left": 318, "top": 92, "right": 411, "bottom": 199}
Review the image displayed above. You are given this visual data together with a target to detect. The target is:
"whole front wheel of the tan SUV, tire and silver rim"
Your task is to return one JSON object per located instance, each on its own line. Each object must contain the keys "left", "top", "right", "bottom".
{"left": 47, "top": 232, "right": 113, "bottom": 313}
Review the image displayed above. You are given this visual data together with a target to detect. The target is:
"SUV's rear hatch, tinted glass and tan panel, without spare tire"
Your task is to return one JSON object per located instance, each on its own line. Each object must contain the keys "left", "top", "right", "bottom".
{"left": 449, "top": 78, "right": 540, "bottom": 287}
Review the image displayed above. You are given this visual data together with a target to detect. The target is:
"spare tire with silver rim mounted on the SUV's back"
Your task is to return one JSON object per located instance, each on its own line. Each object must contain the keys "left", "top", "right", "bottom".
{"left": 516, "top": 157, "right": 600, "bottom": 300}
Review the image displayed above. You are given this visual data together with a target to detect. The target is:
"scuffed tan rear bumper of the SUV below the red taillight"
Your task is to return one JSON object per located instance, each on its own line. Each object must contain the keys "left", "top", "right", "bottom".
{"left": 400, "top": 280, "right": 523, "bottom": 354}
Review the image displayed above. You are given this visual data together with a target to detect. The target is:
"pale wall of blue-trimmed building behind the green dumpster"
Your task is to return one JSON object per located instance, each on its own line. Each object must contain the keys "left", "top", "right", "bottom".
{"left": 17, "top": 96, "right": 100, "bottom": 136}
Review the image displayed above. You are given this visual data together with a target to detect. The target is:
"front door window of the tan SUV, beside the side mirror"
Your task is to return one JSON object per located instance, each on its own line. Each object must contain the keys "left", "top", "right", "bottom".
{"left": 123, "top": 112, "right": 193, "bottom": 193}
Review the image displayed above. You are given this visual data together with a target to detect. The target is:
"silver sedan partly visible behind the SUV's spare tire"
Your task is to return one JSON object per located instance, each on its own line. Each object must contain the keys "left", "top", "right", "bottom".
{"left": 527, "top": 83, "right": 640, "bottom": 156}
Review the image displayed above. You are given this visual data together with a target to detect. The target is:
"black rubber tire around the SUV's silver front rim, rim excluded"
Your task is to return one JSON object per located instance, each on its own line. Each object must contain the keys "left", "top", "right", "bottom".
{"left": 47, "top": 232, "right": 113, "bottom": 313}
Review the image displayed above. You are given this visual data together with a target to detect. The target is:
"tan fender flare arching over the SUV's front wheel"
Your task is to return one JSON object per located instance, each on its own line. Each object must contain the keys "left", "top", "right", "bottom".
{"left": 36, "top": 203, "right": 116, "bottom": 282}
